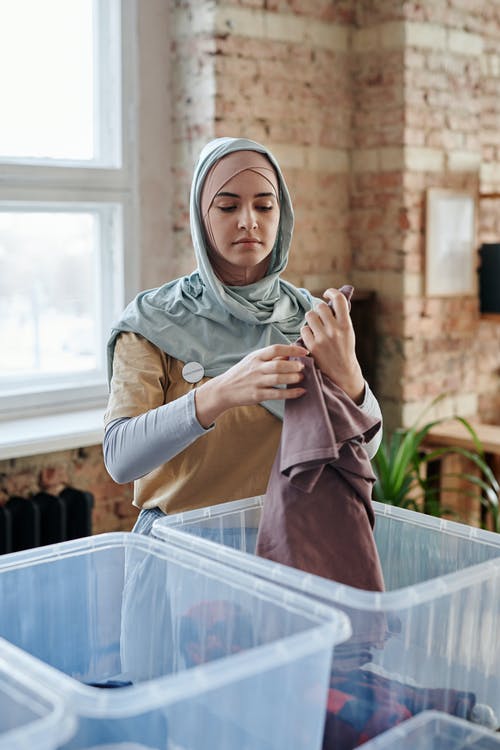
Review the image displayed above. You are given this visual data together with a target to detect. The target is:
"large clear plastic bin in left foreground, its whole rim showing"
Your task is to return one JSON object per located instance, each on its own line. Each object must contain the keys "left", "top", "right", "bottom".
{"left": 0, "top": 533, "right": 350, "bottom": 750}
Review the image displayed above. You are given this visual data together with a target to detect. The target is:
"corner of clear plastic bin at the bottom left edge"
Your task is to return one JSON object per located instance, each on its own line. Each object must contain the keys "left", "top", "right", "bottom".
{"left": 0, "top": 641, "right": 75, "bottom": 750}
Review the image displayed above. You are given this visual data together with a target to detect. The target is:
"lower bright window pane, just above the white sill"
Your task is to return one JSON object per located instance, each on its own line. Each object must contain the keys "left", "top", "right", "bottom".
{"left": 0, "top": 211, "right": 101, "bottom": 381}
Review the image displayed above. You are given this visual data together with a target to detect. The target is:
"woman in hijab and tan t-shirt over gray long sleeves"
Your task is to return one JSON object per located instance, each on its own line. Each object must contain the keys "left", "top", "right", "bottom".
{"left": 104, "top": 138, "right": 381, "bottom": 534}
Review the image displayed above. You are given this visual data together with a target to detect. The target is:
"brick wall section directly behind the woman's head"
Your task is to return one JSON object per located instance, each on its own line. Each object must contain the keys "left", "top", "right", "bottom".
{"left": 170, "top": 2, "right": 353, "bottom": 286}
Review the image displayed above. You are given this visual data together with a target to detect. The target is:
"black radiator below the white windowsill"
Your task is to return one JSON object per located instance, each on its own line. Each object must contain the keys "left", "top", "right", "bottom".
{"left": 0, "top": 487, "right": 94, "bottom": 554}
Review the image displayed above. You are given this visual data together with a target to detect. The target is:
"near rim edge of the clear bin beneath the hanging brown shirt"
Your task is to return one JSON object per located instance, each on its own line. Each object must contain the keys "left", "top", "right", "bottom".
{"left": 153, "top": 519, "right": 500, "bottom": 611}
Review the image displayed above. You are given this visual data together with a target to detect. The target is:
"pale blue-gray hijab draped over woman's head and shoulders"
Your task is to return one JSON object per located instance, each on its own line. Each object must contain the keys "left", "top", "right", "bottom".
{"left": 108, "top": 138, "right": 313, "bottom": 417}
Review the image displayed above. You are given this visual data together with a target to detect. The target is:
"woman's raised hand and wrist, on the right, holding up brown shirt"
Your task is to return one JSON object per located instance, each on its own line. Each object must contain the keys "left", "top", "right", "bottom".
{"left": 300, "top": 289, "right": 365, "bottom": 404}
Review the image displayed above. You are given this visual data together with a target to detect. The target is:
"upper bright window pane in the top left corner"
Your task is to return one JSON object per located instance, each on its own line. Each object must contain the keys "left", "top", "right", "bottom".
{"left": 0, "top": 0, "right": 119, "bottom": 163}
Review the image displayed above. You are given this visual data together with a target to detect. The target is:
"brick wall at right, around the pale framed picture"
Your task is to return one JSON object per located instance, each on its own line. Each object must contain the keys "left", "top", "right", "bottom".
{"left": 352, "top": 2, "right": 498, "bottom": 427}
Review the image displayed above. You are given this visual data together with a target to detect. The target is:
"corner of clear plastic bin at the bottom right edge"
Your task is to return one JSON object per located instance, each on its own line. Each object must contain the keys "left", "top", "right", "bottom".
{"left": 363, "top": 711, "right": 500, "bottom": 750}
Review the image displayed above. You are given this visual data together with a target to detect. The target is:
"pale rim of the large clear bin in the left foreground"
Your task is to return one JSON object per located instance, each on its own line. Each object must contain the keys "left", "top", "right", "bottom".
{"left": 0, "top": 532, "right": 352, "bottom": 717}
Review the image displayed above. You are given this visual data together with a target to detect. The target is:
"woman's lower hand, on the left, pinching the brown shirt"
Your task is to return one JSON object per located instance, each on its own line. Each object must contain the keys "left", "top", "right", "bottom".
{"left": 195, "top": 344, "right": 308, "bottom": 428}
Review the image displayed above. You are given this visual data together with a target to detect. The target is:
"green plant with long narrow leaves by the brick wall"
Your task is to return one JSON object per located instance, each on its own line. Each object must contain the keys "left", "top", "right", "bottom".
{"left": 373, "top": 396, "right": 500, "bottom": 532}
